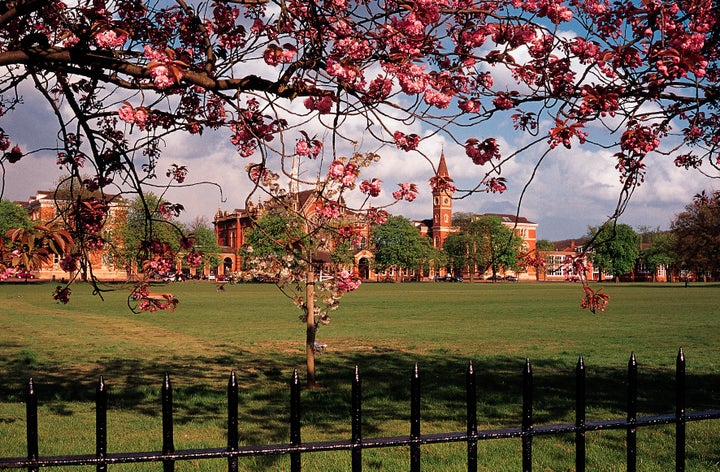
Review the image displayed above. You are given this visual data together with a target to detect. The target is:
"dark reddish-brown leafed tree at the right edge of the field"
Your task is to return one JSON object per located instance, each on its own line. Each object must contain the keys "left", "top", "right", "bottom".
{"left": 671, "top": 191, "right": 720, "bottom": 277}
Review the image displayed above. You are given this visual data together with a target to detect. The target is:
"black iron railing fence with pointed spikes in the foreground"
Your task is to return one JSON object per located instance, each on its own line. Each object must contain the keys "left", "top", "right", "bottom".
{"left": 0, "top": 349, "right": 720, "bottom": 472}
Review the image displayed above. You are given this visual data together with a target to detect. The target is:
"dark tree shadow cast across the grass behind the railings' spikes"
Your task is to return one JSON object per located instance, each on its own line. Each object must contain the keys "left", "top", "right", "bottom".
{"left": 0, "top": 351, "right": 720, "bottom": 467}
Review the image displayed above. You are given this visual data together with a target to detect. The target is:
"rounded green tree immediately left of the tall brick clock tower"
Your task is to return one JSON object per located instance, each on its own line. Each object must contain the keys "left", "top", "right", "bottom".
{"left": 371, "top": 216, "right": 432, "bottom": 279}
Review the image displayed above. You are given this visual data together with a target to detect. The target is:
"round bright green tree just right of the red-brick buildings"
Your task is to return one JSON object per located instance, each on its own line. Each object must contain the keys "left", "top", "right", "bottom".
{"left": 588, "top": 222, "right": 640, "bottom": 282}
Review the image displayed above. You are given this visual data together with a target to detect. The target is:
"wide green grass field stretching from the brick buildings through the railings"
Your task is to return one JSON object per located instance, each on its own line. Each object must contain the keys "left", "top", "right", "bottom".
{"left": 0, "top": 282, "right": 720, "bottom": 472}
